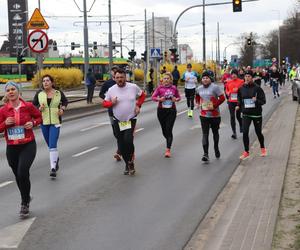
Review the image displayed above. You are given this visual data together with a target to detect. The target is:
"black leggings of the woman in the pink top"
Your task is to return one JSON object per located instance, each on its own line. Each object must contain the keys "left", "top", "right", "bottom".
{"left": 157, "top": 108, "right": 177, "bottom": 149}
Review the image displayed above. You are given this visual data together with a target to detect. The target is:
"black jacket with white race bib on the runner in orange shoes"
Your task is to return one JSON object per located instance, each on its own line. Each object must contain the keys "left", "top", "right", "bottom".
{"left": 238, "top": 83, "right": 266, "bottom": 116}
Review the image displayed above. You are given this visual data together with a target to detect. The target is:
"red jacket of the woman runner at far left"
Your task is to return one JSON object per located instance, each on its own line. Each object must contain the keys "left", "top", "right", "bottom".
{"left": 0, "top": 99, "right": 42, "bottom": 145}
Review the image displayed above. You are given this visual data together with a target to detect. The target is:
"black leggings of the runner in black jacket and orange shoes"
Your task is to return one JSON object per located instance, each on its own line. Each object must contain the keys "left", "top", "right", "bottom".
{"left": 243, "top": 115, "right": 265, "bottom": 152}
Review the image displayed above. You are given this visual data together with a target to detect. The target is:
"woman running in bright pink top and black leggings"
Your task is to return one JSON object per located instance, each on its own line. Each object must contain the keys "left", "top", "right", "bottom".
{"left": 152, "top": 72, "right": 180, "bottom": 158}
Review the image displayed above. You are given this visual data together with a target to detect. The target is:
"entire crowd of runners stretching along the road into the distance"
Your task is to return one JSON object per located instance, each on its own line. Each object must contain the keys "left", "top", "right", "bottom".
{"left": 0, "top": 64, "right": 296, "bottom": 218}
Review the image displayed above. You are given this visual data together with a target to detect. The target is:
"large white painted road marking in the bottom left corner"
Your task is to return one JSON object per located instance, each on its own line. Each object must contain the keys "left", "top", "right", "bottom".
{"left": 0, "top": 217, "right": 36, "bottom": 249}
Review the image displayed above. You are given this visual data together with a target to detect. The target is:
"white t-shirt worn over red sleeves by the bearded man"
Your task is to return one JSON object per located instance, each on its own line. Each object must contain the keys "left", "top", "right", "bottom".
{"left": 105, "top": 82, "right": 142, "bottom": 121}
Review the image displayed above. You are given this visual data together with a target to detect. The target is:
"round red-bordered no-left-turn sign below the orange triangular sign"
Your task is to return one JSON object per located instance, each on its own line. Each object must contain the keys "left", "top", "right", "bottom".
{"left": 27, "top": 30, "right": 48, "bottom": 53}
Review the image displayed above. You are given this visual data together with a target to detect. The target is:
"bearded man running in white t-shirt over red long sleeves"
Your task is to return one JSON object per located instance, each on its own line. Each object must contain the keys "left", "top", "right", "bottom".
{"left": 102, "top": 69, "right": 146, "bottom": 175}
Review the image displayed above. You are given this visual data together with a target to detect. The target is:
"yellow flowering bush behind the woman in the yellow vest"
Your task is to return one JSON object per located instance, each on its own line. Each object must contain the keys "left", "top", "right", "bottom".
{"left": 32, "top": 68, "right": 83, "bottom": 89}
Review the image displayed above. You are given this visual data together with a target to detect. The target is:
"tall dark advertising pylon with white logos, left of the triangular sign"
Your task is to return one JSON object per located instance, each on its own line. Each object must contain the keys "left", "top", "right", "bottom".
{"left": 7, "top": 0, "right": 28, "bottom": 57}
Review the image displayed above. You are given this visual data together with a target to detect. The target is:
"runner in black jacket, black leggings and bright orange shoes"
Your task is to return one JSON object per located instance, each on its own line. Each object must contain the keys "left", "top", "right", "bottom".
{"left": 236, "top": 71, "right": 267, "bottom": 160}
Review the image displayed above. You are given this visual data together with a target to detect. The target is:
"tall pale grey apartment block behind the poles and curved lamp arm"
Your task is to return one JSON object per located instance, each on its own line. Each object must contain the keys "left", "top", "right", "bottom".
{"left": 147, "top": 17, "right": 173, "bottom": 53}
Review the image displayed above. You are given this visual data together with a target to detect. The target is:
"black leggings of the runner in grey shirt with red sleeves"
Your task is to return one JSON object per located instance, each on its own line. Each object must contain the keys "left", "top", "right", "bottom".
{"left": 200, "top": 116, "right": 221, "bottom": 154}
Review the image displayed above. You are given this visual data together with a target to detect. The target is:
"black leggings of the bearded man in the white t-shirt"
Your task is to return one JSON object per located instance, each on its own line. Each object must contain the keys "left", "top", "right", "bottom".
{"left": 113, "top": 119, "right": 136, "bottom": 169}
